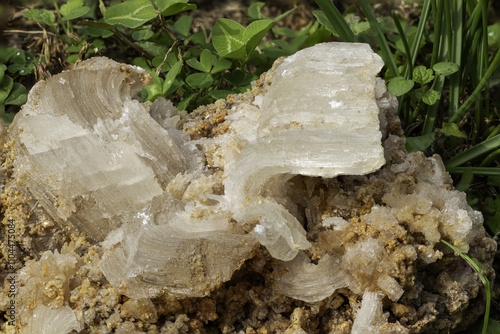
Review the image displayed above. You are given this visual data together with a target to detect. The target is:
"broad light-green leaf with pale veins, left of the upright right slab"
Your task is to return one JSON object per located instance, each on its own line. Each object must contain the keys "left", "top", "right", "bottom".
{"left": 212, "top": 18, "right": 246, "bottom": 60}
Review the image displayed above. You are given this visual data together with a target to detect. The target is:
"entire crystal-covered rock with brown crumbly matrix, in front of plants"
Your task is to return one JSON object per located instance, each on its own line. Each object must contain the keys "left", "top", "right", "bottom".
{"left": 0, "top": 43, "right": 496, "bottom": 334}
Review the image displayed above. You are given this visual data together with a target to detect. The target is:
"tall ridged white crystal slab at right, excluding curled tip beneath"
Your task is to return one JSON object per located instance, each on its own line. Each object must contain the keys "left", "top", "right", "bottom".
{"left": 225, "top": 43, "right": 385, "bottom": 204}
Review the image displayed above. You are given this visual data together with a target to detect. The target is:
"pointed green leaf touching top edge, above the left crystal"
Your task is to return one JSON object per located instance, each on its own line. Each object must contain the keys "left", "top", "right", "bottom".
{"left": 104, "top": 0, "right": 158, "bottom": 28}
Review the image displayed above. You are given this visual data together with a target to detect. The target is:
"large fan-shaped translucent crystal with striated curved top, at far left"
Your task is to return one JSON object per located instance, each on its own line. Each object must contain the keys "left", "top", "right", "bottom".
{"left": 10, "top": 58, "right": 191, "bottom": 241}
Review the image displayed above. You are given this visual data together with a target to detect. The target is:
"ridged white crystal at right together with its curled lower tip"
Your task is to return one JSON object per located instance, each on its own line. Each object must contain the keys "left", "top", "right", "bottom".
{"left": 217, "top": 43, "right": 385, "bottom": 261}
